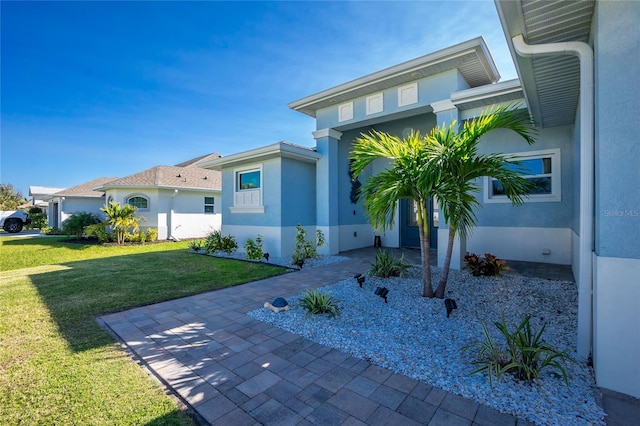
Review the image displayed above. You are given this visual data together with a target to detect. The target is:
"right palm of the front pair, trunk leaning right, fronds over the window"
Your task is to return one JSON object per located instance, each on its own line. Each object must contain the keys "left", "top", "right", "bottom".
{"left": 427, "top": 106, "right": 536, "bottom": 299}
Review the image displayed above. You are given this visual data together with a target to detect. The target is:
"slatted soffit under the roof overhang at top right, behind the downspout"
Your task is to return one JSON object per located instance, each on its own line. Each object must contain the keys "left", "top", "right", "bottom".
{"left": 495, "top": 0, "right": 595, "bottom": 127}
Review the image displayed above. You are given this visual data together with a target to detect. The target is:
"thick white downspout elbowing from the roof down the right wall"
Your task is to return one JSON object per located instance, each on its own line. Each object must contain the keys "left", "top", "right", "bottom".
{"left": 511, "top": 34, "right": 594, "bottom": 359}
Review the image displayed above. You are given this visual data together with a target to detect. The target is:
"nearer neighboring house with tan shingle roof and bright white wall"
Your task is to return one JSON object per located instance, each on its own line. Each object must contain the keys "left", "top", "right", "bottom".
{"left": 94, "top": 154, "right": 221, "bottom": 240}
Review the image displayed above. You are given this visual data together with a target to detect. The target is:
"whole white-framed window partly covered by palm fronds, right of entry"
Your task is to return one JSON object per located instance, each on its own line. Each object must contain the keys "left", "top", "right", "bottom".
{"left": 484, "top": 149, "right": 560, "bottom": 203}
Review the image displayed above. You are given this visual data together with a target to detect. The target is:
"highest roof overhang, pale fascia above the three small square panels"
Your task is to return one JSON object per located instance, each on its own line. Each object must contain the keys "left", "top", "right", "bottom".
{"left": 289, "top": 37, "right": 500, "bottom": 117}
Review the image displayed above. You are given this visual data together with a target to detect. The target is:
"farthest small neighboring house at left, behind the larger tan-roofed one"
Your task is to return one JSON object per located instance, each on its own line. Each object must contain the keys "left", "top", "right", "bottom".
{"left": 44, "top": 177, "right": 117, "bottom": 228}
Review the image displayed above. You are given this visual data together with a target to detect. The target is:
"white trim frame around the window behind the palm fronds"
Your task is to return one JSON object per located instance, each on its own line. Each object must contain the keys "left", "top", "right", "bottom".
{"left": 483, "top": 148, "right": 562, "bottom": 204}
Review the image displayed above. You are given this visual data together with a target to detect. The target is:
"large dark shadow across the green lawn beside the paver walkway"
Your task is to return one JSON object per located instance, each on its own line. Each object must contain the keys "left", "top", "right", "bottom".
{"left": 29, "top": 250, "right": 285, "bottom": 352}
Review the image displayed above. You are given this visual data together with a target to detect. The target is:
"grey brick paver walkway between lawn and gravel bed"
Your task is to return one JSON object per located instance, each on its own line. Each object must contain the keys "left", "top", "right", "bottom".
{"left": 99, "top": 249, "right": 580, "bottom": 426}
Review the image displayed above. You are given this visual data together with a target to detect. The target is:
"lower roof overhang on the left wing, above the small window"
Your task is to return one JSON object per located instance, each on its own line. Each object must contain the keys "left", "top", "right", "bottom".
{"left": 199, "top": 142, "right": 322, "bottom": 170}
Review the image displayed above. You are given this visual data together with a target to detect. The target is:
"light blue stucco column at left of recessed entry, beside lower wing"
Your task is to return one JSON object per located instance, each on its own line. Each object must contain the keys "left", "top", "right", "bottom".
{"left": 313, "top": 129, "right": 342, "bottom": 255}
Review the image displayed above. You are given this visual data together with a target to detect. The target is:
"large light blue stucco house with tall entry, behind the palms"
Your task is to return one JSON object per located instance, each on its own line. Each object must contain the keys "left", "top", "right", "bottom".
{"left": 202, "top": 0, "right": 640, "bottom": 397}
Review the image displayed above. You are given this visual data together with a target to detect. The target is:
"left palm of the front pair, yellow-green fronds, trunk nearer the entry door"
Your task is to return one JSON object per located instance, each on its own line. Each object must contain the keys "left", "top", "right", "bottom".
{"left": 351, "top": 130, "right": 440, "bottom": 297}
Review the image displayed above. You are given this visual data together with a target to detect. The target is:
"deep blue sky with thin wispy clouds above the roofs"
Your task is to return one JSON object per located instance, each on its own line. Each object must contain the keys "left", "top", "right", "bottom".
{"left": 0, "top": 0, "right": 516, "bottom": 200}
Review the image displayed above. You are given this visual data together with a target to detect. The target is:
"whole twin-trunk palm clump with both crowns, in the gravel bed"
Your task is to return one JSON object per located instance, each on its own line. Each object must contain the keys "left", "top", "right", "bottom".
{"left": 350, "top": 107, "right": 535, "bottom": 298}
